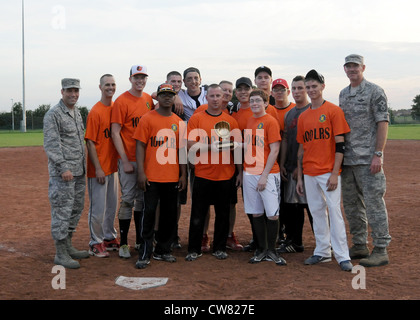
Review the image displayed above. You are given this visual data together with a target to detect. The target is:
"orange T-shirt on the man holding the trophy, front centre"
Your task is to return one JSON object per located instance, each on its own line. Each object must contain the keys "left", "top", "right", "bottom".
{"left": 188, "top": 111, "right": 242, "bottom": 181}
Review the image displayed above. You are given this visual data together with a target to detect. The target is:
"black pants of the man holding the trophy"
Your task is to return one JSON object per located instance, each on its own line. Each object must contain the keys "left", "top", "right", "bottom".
{"left": 188, "top": 177, "right": 233, "bottom": 253}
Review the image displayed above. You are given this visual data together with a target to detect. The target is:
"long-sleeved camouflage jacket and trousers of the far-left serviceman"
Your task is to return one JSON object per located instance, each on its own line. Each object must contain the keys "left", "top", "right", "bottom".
{"left": 44, "top": 100, "right": 86, "bottom": 240}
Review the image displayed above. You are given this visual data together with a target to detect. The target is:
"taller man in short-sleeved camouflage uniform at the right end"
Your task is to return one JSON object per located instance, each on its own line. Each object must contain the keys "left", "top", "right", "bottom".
{"left": 339, "top": 54, "right": 391, "bottom": 267}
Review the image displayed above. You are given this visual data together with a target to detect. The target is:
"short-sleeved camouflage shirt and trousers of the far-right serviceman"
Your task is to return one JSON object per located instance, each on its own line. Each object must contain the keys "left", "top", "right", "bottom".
{"left": 339, "top": 79, "right": 391, "bottom": 248}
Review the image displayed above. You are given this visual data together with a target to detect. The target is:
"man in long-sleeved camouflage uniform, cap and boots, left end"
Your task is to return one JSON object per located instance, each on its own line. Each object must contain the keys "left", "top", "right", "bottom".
{"left": 44, "top": 78, "right": 89, "bottom": 269}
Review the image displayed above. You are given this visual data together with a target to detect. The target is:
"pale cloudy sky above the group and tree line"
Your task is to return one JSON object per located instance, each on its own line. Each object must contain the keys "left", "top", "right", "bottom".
{"left": 0, "top": 0, "right": 420, "bottom": 112}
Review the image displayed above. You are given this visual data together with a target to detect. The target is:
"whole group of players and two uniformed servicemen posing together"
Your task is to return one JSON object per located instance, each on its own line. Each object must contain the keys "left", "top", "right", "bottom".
{"left": 44, "top": 54, "right": 391, "bottom": 271}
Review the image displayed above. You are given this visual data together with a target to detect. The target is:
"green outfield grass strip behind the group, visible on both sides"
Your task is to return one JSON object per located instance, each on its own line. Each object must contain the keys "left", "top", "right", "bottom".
{"left": 0, "top": 124, "right": 420, "bottom": 148}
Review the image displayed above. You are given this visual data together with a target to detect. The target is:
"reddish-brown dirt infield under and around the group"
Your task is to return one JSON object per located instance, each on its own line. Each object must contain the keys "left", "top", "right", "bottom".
{"left": 0, "top": 141, "right": 420, "bottom": 300}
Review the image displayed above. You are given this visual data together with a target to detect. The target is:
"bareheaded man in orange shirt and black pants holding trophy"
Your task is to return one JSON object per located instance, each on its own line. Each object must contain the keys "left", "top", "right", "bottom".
{"left": 185, "top": 84, "right": 242, "bottom": 261}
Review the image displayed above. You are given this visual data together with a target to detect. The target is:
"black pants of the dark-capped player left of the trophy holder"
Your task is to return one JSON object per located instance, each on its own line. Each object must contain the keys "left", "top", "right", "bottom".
{"left": 139, "top": 181, "right": 178, "bottom": 260}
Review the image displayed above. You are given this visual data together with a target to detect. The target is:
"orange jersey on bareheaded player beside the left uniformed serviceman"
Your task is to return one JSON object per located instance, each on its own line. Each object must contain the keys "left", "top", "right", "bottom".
{"left": 85, "top": 101, "right": 118, "bottom": 178}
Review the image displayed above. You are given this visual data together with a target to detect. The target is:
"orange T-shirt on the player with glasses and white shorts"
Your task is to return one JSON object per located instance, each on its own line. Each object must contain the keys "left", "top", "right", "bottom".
{"left": 244, "top": 114, "right": 281, "bottom": 175}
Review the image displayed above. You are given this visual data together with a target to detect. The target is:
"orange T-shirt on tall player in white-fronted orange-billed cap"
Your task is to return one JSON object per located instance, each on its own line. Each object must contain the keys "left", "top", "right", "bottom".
{"left": 111, "top": 91, "right": 154, "bottom": 162}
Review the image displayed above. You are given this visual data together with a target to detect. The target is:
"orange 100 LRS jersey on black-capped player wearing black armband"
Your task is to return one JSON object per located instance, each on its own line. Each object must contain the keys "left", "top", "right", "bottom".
{"left": 296, "top": 101, "right": 350, "bottom": 176}
